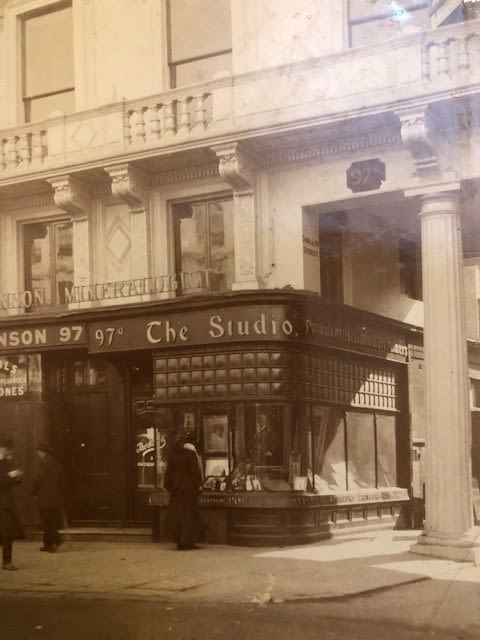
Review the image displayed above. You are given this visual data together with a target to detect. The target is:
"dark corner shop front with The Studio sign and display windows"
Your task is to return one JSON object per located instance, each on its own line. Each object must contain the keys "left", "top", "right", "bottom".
{"left": 0, "top": 291, "right": 410, "bottom": 545}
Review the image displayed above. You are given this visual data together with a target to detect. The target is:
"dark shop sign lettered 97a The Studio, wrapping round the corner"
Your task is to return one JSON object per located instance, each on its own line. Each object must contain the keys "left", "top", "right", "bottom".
{"left": 89, "top": 305, "right": 408, "bottom": 362}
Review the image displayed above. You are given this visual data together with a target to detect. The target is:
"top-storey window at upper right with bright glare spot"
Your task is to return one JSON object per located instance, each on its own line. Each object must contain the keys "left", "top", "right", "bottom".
{"left": 348, "top": 0, "right": 430, "bottom": 47}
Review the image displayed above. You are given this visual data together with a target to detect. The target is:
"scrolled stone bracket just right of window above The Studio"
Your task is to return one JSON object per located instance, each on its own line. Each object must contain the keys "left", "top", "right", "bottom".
{"left": 212, "top": 142, "right": 256, "bottom": 193}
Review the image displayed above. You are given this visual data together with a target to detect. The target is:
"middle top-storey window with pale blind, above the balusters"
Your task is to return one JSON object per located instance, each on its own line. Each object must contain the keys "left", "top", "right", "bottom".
{"left": 168, "top": 0, "right": 232, "bottom": 87}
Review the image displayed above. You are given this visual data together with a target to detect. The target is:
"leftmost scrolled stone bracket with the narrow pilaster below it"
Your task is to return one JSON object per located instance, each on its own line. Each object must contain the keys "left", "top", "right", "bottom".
{"left": 48, "top": 175, "right": 92, "bottom": 306}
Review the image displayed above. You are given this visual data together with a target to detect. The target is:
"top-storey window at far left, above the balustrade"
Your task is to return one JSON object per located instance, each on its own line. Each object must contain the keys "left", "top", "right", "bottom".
{"left": 22, "top": 5, "right": 74, "bottom": 122}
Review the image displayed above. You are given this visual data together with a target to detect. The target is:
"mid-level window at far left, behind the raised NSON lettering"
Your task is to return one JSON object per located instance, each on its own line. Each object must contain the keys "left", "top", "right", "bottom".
{"left": 23, "top": 220, "right": 73, "bottom": 309}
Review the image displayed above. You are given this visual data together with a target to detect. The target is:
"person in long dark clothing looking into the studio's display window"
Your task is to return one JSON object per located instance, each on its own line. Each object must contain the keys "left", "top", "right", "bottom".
{"left": 165, "top": 437, "right": 202, "bottom": 549}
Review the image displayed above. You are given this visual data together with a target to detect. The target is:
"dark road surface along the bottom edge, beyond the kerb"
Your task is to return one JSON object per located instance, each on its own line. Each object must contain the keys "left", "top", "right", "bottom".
{"left": 0, "top": 595, "right": 478, "bottom": 640}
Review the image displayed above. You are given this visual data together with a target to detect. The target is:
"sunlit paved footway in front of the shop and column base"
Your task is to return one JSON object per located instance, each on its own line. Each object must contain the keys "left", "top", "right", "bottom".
{"left": 0, "top": 530, "right": 480, "bottom": 638}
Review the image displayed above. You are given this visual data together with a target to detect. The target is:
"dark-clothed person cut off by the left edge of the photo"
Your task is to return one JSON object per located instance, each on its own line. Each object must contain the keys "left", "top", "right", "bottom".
{"left": 0, "top": 438, "right": 25, "bottom": 571}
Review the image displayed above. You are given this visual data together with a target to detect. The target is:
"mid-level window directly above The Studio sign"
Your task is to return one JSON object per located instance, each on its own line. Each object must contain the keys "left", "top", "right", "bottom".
{"left": 173, "top": 199, "right": 235, "bottom": 295}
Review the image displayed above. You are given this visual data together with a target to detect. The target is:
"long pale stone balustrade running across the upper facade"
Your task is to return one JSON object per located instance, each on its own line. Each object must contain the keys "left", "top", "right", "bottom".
{"left": 0, "top": 20, "right": 480, "bottom": 184}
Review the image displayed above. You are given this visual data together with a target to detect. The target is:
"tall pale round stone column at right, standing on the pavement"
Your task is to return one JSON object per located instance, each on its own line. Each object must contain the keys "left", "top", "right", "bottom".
{"left": 411, "top": 191, "right": 480, "bottom": 564}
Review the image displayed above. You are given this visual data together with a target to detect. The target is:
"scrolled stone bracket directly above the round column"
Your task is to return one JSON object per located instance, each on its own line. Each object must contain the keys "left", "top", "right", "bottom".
{"left": 397, "top": 107, "right": 438, "bottom": 177}
